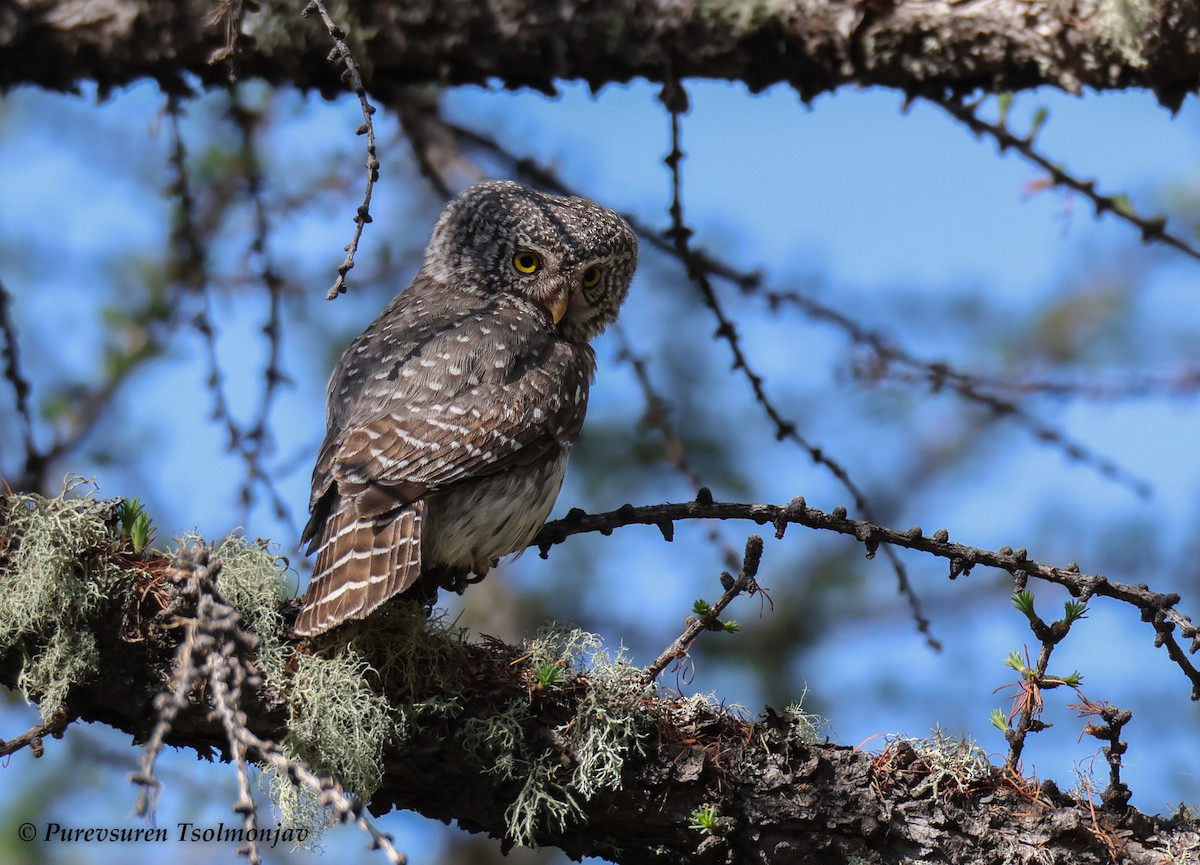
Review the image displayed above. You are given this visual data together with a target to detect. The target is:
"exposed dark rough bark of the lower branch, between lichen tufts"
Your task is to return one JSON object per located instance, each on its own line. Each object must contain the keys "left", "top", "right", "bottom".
{"left": 0, "top": 587, "right": 1200, "bottom": 865}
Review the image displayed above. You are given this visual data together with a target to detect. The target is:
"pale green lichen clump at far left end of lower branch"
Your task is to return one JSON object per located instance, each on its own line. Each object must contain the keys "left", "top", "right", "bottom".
{"left": 0, "top": 479, "right": 132, "bottom": 719}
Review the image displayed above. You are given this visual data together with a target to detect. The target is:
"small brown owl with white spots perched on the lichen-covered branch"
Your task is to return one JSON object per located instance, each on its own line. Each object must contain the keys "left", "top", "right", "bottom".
{"left": 294, "top": 181, "right": 637, "bottom": 636}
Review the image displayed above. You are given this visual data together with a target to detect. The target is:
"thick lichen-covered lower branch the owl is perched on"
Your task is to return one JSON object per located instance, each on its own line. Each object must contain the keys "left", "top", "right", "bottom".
{"left": 0, "top": 497, "right": 1200, "bottom": 865}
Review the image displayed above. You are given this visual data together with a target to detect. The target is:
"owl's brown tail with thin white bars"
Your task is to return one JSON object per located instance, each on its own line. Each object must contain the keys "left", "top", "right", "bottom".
{"left": 295, "top": 498, "right": 425, "bottom": 637}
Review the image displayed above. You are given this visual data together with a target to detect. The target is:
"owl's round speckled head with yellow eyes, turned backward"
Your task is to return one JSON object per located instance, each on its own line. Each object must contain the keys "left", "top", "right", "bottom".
{"left": 425, "top": 180, "right": 637, "bottom": 341}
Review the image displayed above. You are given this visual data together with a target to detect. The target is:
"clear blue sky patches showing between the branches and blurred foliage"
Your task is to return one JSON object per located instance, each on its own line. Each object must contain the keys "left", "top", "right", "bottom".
{"left": 0, "top": 77, "right": 1200, "bottom": 861}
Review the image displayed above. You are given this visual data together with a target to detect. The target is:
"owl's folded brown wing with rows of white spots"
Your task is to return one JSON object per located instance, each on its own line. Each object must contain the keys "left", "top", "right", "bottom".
{"left": 330, "top": 347, "right": 592, "bottom": 491}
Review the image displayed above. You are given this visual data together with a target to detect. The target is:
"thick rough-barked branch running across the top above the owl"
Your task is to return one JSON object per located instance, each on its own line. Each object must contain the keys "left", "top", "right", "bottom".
{"left": 7, "top": 0, "right": 1200, "bottom": 104}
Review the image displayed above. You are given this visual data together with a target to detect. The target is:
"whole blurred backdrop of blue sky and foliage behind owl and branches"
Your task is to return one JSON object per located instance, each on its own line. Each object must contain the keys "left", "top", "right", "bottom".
{"left": 0, "top": 75, "right": 1200, "bottom": 863}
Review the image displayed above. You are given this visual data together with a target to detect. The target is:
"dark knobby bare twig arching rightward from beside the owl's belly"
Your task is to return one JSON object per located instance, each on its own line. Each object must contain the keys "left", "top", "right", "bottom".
{"left": 530, "top": 489, "right": 1200, "bottom": 699}
